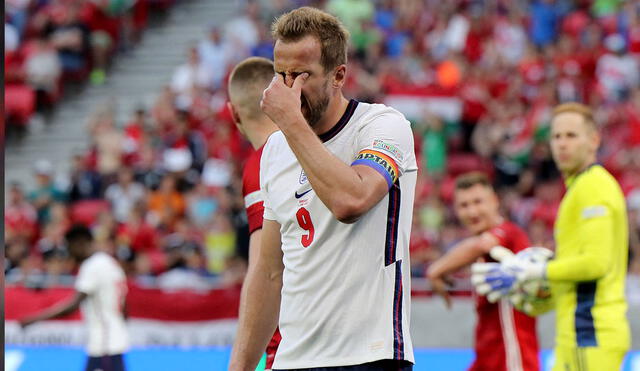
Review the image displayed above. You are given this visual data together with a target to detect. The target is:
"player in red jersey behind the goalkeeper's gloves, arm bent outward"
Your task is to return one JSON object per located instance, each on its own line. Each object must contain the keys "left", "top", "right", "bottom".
{"left": 427, "top": 172, "right": 540, "bottom": 371}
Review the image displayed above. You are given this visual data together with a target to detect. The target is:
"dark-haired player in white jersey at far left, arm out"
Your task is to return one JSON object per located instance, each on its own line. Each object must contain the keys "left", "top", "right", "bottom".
{"left": 20, "top": 226, "right": 129, "bottom": 371}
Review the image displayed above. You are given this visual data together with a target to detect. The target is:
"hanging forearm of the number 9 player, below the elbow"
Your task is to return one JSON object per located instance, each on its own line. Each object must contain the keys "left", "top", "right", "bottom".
{"left": 229, "top": 266, "right": 282, "bottom": 371}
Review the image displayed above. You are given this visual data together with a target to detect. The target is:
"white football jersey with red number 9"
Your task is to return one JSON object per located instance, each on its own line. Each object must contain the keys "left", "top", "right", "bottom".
{"left": 260, "top": 100, "right": 417, "bottom": 369}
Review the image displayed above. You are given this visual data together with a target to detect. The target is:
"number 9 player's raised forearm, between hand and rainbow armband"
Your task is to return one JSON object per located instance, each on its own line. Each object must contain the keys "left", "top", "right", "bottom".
{"left": 284, "top": 120, "right": 373, "bottom": 221}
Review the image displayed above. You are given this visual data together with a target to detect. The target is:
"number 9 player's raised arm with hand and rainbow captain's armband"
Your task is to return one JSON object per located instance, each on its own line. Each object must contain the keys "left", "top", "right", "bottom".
{"left": 261, "top": 73, "right": 413, "bottom": 223}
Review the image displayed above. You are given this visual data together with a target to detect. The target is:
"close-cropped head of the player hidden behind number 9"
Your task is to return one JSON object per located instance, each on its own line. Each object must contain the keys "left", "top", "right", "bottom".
{"left": 228, "top": 57, "right": 274, "bottom": 120}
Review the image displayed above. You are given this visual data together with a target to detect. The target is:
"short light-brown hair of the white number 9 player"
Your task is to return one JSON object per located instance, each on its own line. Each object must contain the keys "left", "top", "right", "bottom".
{"left": 271, "top": 6, "right": 349, "bottom": 72}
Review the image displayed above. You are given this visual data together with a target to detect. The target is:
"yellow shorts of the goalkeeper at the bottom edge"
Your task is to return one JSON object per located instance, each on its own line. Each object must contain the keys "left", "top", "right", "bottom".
{"left": 553, "top": 347, "right": 626, "bottom": 371}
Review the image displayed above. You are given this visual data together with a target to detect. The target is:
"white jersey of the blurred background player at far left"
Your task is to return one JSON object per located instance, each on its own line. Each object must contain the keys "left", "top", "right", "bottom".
{"left": 75, "top": 252, "right": 129, "bottom": 357}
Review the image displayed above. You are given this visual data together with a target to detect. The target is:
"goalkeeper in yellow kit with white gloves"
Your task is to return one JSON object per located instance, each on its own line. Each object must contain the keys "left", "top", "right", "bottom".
{"left": 474, "top": 103, "right": 631, "bottom": 371}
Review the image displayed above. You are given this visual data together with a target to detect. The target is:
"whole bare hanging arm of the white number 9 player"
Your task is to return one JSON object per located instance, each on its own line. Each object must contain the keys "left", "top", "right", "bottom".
{"left": 229, "top": 219, "right": 284, "bottom": 371}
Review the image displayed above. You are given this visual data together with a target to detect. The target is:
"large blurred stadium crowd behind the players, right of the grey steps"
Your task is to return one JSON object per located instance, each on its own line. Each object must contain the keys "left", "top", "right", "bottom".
{"left": 5, "top": 0, "right": 640, "bottom": 296}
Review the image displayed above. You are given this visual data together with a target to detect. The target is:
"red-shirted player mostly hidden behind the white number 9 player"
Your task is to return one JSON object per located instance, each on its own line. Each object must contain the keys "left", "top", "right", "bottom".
{"left": 227, "top": 57, "right": 281, "bottom": 369}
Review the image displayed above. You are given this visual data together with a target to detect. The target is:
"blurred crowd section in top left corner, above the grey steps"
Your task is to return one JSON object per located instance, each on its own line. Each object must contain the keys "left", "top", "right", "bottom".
{"left": 4, "top": 0, "right": 173, "bottom": 126}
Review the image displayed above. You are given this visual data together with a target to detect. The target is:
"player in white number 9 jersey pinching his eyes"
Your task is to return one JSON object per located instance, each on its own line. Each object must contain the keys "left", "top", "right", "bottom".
{"left": 230, "top": 7, "right": 417, "bottom": 370}
